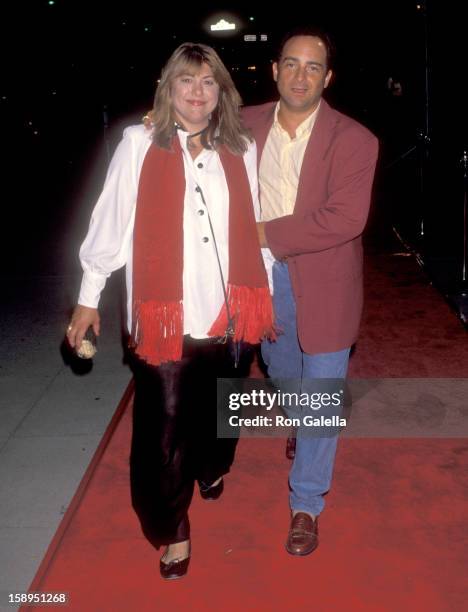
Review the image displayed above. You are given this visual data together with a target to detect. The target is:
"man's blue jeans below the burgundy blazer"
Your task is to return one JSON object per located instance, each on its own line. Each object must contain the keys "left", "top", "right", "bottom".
{"left": 262, "top": 262, "right": 350, "bottom": 516}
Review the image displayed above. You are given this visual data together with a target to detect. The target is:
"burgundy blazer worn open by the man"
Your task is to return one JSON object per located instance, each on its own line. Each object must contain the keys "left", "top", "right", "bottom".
{"left": 243, "top": 100, "right": 378, "bottom": 354}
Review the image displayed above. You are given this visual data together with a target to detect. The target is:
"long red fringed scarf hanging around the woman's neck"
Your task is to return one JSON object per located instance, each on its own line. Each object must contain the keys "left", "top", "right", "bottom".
{"left": 132, "top": 138, "right": 274, "bottom": 365}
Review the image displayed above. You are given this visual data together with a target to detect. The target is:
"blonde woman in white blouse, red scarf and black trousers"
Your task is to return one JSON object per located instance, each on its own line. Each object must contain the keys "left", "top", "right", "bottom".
{"left": 67, "top": 43, "right": 272, "bottom": 579}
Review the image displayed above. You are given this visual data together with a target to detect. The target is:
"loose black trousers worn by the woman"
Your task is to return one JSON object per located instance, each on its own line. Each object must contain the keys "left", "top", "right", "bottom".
{"left": 130, "top": 336, "right": 252, "bottom": 548}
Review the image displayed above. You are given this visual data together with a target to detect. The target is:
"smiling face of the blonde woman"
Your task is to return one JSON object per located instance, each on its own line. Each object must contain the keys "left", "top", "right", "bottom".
{"left": 171, "top": 64, "right": 219, "bottom": 134}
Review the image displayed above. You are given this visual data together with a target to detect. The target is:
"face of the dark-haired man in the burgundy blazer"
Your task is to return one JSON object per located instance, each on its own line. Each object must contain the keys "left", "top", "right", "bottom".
{"left": 273, "top": 36, "right": 332, "bottom": 114}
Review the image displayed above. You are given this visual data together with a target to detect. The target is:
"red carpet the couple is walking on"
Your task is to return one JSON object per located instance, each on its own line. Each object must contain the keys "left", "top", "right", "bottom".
{"left": 24, "top": 256, "right": 468, "bottom": 612}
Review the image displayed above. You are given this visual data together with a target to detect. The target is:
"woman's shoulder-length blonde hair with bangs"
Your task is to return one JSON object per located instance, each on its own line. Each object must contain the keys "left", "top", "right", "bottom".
{"left": 150, "top": 43, "right": 252, "bottom": 155}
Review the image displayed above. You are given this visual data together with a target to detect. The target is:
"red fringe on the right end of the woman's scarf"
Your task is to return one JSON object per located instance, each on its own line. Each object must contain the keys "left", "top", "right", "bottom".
{"left": 208, "top": 284, "right": 276, "bottom": 344}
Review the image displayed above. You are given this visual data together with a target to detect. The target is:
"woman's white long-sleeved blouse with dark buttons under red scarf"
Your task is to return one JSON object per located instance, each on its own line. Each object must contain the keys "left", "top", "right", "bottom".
{"left": 78, "top": 125, "right": 260, "bottom": 338}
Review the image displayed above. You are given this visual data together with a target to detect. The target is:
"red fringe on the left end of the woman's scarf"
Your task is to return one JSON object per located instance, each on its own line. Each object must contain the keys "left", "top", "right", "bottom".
{"left": 132, "top": 301, "right": 184, "bottom": 366}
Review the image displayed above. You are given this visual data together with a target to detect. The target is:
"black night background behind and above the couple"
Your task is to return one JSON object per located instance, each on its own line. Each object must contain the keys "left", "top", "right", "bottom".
{"left": 0, "top": 0, "right": 468, "bottom": 296}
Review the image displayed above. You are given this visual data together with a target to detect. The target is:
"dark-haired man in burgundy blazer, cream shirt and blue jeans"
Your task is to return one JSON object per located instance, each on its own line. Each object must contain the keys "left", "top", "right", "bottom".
{"left": 244, "top": 28, "right": 378, "bottom": 555}
